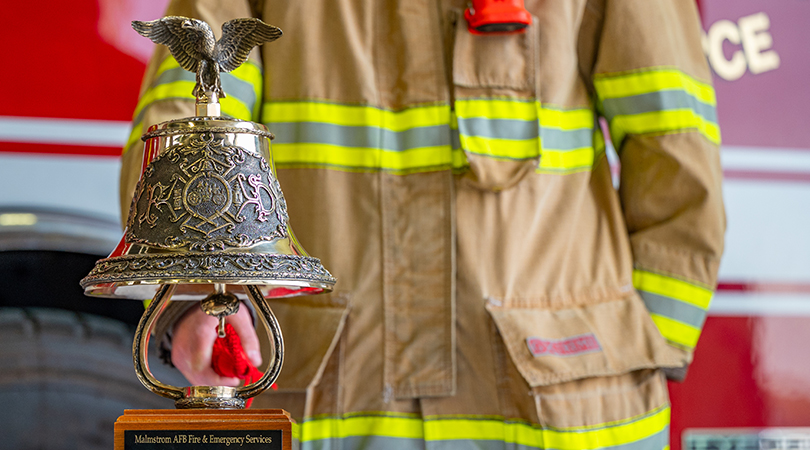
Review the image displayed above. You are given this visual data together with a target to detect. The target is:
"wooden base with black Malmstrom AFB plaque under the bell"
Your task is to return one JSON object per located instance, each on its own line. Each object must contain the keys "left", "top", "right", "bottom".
{"left": 115, "top": 409, "right": 292, "bottom": 450}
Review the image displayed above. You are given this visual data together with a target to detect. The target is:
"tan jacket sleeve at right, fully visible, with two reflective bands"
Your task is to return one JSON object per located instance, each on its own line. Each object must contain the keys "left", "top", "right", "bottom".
{"left": 589, "top": 0, "right": 725, "bottom": 365}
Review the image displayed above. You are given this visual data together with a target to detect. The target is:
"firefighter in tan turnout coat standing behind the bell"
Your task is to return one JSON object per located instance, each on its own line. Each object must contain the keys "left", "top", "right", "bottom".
{"left": 121, "top": 0, "right": 725, "bottom": 450}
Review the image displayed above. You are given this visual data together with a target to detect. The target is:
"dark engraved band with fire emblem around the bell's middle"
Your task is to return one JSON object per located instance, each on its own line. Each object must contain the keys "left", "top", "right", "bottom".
{"left": 127, "top": 132, "right": 287, "bottom": 251}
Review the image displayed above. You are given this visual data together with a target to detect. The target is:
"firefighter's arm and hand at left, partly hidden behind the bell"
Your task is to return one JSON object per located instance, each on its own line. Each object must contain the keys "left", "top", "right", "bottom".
{"left": 120, "top": 0, "right": 263, "bottom": 385}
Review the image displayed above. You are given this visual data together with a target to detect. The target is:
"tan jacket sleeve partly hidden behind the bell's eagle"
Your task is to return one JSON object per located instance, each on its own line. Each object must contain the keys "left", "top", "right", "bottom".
{"left": 120, "top": 0, "right": 263, "bottom": 223}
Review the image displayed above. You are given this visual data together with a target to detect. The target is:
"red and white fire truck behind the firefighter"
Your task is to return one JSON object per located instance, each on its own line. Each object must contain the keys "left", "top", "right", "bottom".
{"left": 0, "top": 0, "right": 810, "bottom": 450}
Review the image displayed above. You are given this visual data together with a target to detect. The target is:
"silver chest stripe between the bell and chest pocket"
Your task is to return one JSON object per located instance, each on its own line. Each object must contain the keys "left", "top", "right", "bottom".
{"left": 266, "top": 122, "right": 451, "bottom": 151}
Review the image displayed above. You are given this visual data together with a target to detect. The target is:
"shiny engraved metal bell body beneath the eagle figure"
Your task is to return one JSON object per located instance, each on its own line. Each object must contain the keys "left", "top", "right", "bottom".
{"left": 81, "top": 116, "right": 335, "bottom": 300}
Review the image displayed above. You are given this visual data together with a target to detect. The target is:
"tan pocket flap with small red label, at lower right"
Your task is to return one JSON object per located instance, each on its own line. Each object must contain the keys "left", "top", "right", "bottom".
{"left": 487, "top": 295, "right": 685, "bottom": 387}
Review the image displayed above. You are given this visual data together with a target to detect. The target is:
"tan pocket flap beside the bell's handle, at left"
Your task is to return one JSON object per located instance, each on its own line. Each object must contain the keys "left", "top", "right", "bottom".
{"left": 262, "top": 294, "right": 349, "bottom": 392}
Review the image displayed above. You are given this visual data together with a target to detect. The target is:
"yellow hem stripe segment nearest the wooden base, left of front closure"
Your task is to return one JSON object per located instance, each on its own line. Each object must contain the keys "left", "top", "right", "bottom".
{"left": 301, "top": 413, "right": 424, "bottom": 442}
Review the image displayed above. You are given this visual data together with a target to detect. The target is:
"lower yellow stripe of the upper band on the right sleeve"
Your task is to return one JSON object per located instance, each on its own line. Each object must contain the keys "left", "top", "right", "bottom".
{"left": 611, "top": 109, "right": 720, "bottom": 145}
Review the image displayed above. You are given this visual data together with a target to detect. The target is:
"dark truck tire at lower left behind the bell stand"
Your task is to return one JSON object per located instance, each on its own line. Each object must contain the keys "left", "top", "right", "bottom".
{"left": 0, "top": 308, "right": 185, "bottom": 450}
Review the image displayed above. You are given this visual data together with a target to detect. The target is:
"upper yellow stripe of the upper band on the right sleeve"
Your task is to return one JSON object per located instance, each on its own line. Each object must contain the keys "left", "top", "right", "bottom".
{"left": 594, "top": 68, "right": 717, "bottom": 106}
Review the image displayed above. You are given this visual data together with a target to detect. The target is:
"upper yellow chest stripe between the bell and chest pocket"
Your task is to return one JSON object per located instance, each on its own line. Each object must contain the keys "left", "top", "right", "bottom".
{"left": 262, "top": 101, "right": 450, "bottom": 131}
